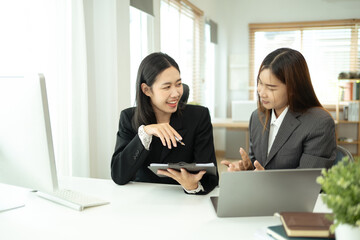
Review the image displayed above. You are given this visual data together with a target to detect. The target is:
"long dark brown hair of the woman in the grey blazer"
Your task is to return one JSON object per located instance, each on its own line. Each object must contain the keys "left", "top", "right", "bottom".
{"left": 257, "top": 48, "right": 322, "bottom": 126}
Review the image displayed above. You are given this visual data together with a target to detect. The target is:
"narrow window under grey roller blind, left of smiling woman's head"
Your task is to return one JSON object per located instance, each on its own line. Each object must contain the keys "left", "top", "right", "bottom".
{"left": 130, "top": 7, "right": 153, "bottom": 104}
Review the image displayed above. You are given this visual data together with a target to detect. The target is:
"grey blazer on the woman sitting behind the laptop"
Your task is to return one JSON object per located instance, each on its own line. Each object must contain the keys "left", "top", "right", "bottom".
{"left": 249, "top": 108, "right": 336, "bottom": 169}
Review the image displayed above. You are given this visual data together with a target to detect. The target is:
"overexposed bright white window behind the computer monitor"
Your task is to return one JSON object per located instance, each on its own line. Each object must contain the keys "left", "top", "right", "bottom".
{"left": 0, "top": 0, "right": 71, "bottom": 175}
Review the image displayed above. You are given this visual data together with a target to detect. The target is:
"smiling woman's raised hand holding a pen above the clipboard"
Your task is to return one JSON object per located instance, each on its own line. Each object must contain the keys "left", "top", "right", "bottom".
{"left": 144, "top": 123, "right": 182, "bottom": 149}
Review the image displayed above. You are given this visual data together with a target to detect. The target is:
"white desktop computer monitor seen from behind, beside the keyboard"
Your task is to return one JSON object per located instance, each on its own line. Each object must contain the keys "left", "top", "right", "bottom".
{"left": 0, "top": 74, "right": 58, "bottom": 193}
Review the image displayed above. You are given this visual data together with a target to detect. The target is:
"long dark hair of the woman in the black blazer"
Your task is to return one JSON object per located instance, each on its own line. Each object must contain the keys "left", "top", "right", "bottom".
{"left": 132, "top": 52, "right": 182, "bottom": 130}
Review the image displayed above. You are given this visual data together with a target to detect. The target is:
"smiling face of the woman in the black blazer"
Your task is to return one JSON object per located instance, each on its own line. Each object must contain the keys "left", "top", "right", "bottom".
{"left": 141, "top": 67, "right": 183, "bottom": 123}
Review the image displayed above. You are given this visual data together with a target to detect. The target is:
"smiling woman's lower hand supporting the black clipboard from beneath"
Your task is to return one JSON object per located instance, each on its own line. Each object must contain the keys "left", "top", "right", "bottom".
{"left": 157, "top": 168, "right": 206, "bottom": 190}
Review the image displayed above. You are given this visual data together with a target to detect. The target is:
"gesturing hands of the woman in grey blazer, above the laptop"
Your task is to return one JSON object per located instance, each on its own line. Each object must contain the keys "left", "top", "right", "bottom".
{"left": 221, "top": 148, "right": 265, "bottom": 172}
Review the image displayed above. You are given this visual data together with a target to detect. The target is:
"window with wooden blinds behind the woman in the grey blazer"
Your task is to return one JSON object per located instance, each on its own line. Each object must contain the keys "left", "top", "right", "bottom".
{"left": 249, "top": 19, "right": 360, "bottom": 104}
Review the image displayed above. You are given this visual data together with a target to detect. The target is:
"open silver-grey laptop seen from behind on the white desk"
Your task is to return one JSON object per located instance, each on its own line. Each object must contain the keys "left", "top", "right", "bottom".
{"left": 210, "top": 168, "right": 321, "bottom": 217}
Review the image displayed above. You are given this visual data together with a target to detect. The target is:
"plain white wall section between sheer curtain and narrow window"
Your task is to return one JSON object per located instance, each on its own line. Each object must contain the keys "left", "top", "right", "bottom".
{"left": 83, "top": 0, "right": 130, "bottom": 178}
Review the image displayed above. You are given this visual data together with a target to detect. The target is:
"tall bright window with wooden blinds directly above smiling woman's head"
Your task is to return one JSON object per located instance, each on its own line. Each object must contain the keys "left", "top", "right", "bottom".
{"left": 160, "top": 0, "right": 204, "bottom": 104}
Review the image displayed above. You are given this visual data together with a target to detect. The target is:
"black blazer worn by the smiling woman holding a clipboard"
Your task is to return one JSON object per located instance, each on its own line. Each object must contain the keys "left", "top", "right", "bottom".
{"left": 111, "top": 105, "right": 218, "bottom": 194}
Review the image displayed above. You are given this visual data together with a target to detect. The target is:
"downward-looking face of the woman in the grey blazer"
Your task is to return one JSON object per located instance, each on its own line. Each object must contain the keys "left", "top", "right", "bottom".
{"left": 257, "top": 69, "right": 288, "bottom": 117}
